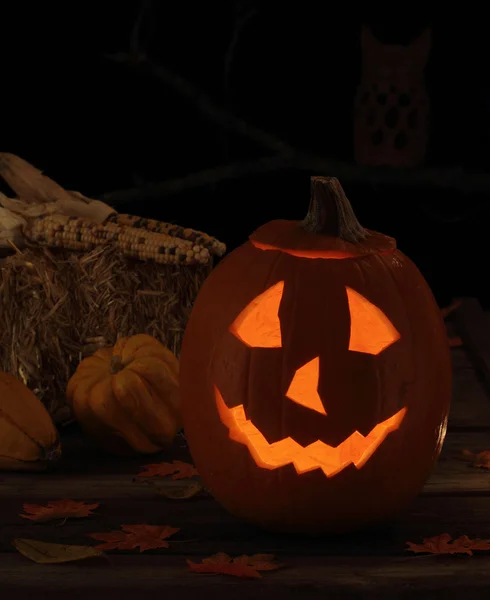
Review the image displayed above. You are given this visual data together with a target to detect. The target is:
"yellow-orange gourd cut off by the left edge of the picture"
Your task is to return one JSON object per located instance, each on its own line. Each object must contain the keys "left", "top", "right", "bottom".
{"left": 0, "top": 373, "right": 61, "bottom": 471}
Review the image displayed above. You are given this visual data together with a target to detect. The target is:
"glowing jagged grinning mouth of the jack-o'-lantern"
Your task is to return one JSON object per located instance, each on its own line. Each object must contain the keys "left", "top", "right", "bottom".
{"left": 214, "top": 386, "right": 407, "bottom": 477}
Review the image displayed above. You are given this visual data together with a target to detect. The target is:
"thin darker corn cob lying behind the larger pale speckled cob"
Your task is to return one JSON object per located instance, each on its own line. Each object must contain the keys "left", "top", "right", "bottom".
{"left": 104, "top": 213, "right": 226, "bottom": 256}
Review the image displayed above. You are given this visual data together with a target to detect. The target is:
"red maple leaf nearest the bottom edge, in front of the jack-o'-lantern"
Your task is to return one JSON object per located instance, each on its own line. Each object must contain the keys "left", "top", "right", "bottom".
{"left": 187, "top": 552, "right": 284, "bottom": 579}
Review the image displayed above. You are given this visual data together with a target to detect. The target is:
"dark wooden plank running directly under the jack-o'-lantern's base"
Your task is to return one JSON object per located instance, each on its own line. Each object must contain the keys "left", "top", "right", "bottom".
{"left": 0, "top": 496, "right": 490, "bottom": 557}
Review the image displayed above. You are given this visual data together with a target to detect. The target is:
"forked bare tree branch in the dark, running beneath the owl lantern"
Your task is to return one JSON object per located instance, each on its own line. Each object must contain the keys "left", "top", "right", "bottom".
{"left": 102, "top": 5, "right": 490, "bottom": 218}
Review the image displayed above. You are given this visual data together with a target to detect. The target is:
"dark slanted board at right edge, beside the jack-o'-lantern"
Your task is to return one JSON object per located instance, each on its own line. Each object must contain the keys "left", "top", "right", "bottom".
{"left": 453, "top": 298, "right": 490, "bottom": 388}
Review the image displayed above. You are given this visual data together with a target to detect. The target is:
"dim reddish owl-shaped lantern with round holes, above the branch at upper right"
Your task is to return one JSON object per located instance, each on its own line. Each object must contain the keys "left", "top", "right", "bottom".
{"left": 354, "top": 26, "right": 431, "bottom": 167}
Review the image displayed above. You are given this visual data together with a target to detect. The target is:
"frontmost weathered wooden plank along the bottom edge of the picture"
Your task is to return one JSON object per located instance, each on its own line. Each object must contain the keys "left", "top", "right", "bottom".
{"left": 0, "top": 555, "right": 490, "bottom": 600}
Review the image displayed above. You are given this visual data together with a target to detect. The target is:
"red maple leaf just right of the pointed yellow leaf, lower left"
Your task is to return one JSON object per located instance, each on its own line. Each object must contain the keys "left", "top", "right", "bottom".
{"left": 89, "top": 524, "right": 180, "bottom": 552}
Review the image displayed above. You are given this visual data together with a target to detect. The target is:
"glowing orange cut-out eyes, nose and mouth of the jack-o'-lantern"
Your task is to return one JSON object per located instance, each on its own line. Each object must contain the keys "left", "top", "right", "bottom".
{"left": 214, "top": 281, "right": 407, "bottom": 477}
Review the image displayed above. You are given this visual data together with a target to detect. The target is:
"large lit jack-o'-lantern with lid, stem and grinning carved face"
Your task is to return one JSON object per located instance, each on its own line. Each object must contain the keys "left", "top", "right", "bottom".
{"left": 180, "top": 177, "right": 451, "bottom": 533}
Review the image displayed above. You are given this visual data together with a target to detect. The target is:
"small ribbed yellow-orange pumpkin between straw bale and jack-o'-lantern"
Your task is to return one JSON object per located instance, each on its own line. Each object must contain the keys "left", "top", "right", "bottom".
{"left": 66, "top": 334, "right": 181, "bottom": 454}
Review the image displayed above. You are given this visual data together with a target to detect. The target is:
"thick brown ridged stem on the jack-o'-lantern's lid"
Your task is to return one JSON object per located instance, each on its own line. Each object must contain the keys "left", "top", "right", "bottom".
{"left": 301, "top": 177, "right": 368, "bottom": 244}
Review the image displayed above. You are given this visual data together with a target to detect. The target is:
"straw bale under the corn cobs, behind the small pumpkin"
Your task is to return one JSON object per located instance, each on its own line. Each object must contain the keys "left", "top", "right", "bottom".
{"left": 0, "top": 245, "right": 212, "bottom": 423}
